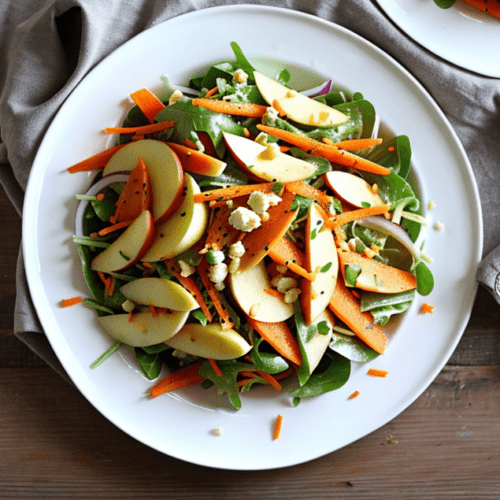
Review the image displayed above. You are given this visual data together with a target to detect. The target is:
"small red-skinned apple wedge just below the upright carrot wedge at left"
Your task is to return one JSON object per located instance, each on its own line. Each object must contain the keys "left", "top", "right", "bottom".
{"left": 91, "top": 210, "right": 154, "bottom": 273}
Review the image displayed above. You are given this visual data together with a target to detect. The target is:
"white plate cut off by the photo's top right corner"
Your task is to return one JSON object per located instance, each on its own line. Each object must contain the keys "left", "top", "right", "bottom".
{"left": 377, "top": 0, "right": 500, "bottom": 78}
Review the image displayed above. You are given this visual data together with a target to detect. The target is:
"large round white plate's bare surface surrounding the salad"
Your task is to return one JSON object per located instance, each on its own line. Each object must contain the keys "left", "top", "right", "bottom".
{"left": 23, "top": 6, "right": 482, "bottom": 469}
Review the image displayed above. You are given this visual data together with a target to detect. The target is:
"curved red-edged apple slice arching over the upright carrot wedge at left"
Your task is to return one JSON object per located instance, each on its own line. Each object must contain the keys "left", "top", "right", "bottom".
{"left": 102, "top": 139, "right": 184, "bottom": 225}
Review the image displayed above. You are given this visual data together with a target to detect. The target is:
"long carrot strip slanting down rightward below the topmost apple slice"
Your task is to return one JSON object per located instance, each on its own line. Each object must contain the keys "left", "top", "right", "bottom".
{"left": 257, "top": 125, "right": 391, "bottom": 175}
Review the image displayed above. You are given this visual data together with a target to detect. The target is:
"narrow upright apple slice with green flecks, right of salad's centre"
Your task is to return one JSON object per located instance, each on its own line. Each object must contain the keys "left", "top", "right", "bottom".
{"left": 300, "top": 204, "right": 339, "bottom": 325}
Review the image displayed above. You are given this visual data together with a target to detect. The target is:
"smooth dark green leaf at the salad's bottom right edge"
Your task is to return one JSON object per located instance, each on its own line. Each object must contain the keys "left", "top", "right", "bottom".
{"left": 290, "top": 352, "right": 351, "bottom": 398}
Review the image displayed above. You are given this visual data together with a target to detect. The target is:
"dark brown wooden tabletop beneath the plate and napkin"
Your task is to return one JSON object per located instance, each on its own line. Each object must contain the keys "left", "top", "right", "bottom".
{"left": 0, "top": 184, "right": 500, "bottom": 500}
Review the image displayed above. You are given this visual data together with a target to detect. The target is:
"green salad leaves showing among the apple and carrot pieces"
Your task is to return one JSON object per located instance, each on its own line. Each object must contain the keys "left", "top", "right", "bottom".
{"left": 75, "top": 43, "right": 433, "bottom": 409}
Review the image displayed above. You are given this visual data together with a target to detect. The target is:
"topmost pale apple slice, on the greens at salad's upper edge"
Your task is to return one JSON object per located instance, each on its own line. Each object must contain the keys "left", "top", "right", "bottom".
{"left": 253, "top": 71, "right": 349, "bottom": 127}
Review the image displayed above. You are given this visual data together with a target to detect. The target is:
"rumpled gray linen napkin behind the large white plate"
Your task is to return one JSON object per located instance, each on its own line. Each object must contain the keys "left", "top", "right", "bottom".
{"left": 0, "top": 0, "right": 500, "bottom": 376}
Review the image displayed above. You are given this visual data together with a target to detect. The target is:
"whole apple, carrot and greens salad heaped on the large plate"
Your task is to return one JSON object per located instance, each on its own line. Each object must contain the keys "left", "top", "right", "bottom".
{"left": 66, "top": 42, "right": 433, "bottom": 409}
